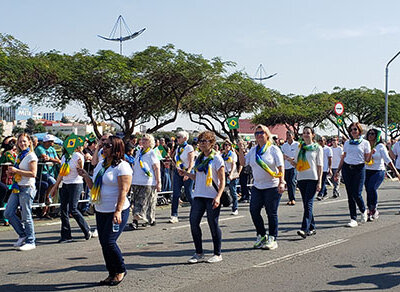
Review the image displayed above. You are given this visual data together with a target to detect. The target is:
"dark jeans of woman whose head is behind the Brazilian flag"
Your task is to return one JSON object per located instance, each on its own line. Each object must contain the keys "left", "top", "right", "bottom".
{"left": 60, "top": 183, "right": 90, "bottom": 239}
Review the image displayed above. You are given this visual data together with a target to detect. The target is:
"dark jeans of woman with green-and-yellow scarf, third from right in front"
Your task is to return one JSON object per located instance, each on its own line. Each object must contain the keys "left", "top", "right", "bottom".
{"left": 297, "top": 179, "right": 318, "bottom": 232}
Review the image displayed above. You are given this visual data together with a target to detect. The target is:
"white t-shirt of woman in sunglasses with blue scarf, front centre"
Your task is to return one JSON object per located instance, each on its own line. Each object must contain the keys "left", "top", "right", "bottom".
{"left": 192, "top": 154, "right": 224, "bottom": 199}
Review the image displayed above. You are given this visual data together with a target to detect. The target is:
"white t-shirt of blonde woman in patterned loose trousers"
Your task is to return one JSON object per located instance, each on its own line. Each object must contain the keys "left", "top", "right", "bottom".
{"left": 132, "top": 149, "right": 160, "bottom": 186}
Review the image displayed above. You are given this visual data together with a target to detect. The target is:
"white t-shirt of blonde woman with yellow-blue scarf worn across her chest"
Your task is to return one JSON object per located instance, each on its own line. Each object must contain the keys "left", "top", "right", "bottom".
{"left": 245, "top": 145, "right": 284, "bottom": 190}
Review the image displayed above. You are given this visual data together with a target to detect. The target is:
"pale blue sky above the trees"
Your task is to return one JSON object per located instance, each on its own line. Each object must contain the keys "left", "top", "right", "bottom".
{"left": 0, "top": 0, "right": 400, "bottom": 128}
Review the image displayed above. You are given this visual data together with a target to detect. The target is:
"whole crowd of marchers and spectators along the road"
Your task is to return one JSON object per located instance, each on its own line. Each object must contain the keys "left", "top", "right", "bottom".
{"left": 0, "top": 122, "right": 400, "bottom": 286}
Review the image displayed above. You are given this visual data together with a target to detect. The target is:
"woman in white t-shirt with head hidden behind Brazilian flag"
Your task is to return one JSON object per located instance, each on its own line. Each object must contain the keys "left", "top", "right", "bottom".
{"left": 50, "top": 146, "right": 94, "bottom": 243}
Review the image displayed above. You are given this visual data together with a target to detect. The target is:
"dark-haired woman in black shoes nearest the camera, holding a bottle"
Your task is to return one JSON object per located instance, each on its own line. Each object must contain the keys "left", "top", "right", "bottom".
{"left": 78, "top": 136, "right": 132, "bottom": 286}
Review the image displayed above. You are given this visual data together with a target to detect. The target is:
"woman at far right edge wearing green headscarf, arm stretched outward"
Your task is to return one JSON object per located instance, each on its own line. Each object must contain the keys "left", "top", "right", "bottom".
{"left": 365, "top": 129, "right": 400, "bottom": 221}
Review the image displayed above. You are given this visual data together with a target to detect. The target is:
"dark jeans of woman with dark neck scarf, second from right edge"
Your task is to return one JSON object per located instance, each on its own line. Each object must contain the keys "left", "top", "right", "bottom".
{"left": 343, "top": 163, "right": 365, "bottom": 220}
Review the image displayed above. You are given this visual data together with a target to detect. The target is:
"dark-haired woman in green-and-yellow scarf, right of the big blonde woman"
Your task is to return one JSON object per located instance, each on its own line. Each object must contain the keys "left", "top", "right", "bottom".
{"left": 291, "top": 127, "right": 324, "bottom": 238}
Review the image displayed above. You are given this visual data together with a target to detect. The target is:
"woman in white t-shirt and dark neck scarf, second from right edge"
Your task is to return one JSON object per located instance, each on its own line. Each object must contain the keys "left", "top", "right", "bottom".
{"left": 335, "top": 122, "right": 372, "bottom": 227}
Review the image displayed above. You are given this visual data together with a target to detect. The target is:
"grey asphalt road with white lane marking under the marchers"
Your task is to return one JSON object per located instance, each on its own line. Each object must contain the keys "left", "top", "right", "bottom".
{"left": 0, "top": 181, "right": 400, "bottom": 292}
